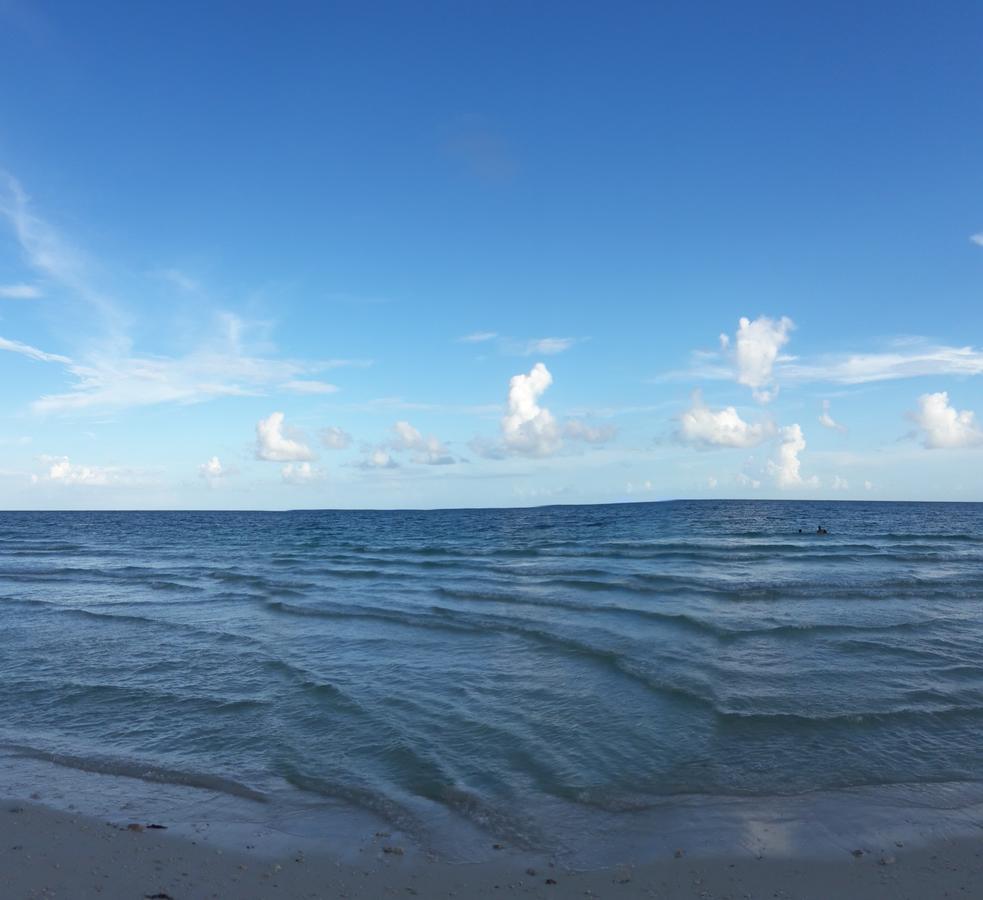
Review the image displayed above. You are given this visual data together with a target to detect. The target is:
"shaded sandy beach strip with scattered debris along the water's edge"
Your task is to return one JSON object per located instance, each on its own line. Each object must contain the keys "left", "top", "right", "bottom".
{"left": 0, "top": 799, "right": 983, "bottom": 900}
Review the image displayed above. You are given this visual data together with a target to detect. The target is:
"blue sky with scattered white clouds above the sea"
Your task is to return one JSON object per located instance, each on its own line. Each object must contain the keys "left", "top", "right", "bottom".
{"left": 0, "top": 0, "right": 983, "bottom": 509}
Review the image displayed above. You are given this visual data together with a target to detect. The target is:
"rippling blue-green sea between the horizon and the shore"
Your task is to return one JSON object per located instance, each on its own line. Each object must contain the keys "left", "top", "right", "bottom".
{"left": 0, "top": 501, "right": 983, "bottom": 842}
